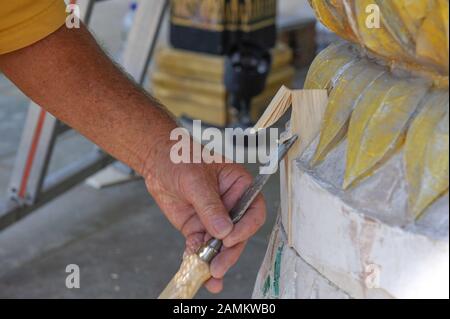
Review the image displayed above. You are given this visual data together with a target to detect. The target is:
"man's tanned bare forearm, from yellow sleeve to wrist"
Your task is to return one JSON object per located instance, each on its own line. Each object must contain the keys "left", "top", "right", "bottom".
{"left": 0, "top": 27, "right": 176, "bottom": 174}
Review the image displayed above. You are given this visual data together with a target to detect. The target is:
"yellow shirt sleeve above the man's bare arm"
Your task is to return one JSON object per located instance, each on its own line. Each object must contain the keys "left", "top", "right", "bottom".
{"left": 0, "top": 0, "right": 66, "bottom": 54}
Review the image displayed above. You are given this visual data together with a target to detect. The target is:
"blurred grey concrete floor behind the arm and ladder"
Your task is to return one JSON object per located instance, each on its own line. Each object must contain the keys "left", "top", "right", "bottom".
{"left": 0, "top": 0, "right": 310, "bottom": 298}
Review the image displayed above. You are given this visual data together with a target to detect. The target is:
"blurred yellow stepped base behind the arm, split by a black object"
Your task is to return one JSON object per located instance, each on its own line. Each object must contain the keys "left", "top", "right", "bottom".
{"left": 150, "top": 45, "right": 295, "bottom": 127}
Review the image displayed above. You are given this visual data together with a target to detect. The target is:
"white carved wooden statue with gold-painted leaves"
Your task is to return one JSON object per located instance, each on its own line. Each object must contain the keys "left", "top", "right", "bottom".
{"left": 254, "top": 0, "right": 449, "bottom": 298}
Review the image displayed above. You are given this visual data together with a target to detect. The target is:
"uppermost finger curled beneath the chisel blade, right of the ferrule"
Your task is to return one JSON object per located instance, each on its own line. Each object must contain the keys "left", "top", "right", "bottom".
{"left": 223, "top": 194, "right": 266, "bottom": 247}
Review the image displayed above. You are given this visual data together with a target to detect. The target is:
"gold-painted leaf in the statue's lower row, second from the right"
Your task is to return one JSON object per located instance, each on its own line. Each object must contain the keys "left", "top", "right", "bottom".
{"left": 343, "top": 74, "right": 428, "bottom": 188}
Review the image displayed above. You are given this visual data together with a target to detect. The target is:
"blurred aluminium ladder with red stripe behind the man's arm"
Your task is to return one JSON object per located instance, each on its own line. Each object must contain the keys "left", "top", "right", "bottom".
{"left": 0, "top": 0, "right": 168, "bottom": 230}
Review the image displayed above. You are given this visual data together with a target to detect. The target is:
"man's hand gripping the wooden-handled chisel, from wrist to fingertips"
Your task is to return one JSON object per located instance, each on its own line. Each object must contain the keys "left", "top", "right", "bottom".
{"left": 144, "top": 140, "right": 266, "bottom": 293}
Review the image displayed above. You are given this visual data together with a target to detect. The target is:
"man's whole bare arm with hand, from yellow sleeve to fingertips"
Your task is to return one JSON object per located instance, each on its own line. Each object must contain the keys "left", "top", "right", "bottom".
{"left": 0, "top": 27, "right": 265, "bottom": 292}
